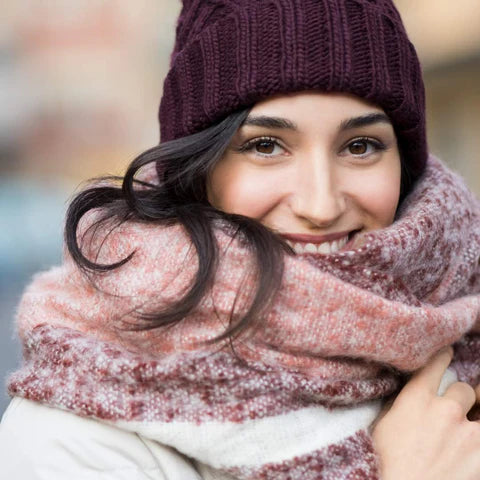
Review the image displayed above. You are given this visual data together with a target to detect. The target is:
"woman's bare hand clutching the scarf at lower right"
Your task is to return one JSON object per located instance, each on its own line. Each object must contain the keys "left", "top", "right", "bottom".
{"left": 372, "top": 347, "right": 480, "bottom": 480}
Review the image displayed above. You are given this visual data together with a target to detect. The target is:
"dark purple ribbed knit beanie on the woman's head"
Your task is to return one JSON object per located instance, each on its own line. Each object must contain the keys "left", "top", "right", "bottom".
{"left": 159, "top": 0, "right": 428, "bottom": 177}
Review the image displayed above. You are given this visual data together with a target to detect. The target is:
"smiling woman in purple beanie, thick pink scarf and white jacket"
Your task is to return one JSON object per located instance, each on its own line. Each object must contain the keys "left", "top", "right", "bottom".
{"left": 0, "top": 0, "right": 480, "bottom": 480}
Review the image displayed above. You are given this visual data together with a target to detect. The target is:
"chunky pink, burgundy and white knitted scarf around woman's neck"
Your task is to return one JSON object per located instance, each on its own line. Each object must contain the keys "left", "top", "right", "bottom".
{"left": 8, "top": 155, "right": 480, "bottom": 480}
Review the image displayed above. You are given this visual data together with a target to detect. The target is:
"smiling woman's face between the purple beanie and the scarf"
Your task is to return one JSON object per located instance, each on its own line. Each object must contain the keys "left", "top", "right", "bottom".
{"left": 207, "top": 91, "right": 401, "bottom": 253}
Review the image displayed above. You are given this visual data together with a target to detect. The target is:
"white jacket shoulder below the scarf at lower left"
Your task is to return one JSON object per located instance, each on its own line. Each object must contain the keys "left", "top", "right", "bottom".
{"left": 0, "top": 397, "right": 201, "bottom": 480}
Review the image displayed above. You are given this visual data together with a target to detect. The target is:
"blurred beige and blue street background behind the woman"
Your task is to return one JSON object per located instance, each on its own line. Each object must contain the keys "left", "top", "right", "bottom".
{"left": 0, "top": 0, "right": 480, "bottom": 414}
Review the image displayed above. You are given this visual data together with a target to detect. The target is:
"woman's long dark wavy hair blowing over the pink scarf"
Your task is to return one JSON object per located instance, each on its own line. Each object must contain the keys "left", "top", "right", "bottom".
{"left": 64, "top": 107, "right": 412, "bottom": 342}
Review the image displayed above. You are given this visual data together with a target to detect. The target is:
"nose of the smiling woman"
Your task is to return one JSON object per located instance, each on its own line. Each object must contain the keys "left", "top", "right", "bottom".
{"left": 291, "top": 155, "right": 347, "bottom": 228}
